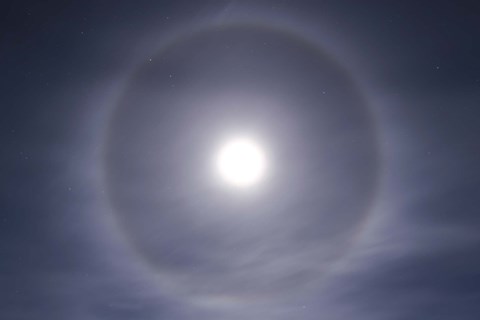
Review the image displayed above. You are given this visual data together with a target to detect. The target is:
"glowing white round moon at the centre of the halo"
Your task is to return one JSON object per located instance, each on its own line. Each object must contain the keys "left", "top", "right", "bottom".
{"left": 216, "top": 138, "right": 266, "bottom": 188}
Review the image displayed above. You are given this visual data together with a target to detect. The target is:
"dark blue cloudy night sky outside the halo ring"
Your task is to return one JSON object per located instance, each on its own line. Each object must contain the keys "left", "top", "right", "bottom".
{"left": 0, "top": 1, "right": 480, "bottom": 320}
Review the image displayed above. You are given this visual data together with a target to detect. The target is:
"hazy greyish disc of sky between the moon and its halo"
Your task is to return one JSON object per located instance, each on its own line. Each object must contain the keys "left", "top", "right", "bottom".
{"left": 105, "top": 25, "right": 379, "bottom": 301}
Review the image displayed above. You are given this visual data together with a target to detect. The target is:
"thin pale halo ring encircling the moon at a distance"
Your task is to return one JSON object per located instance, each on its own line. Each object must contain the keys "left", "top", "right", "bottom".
{"left": 103, "top": 18, "right": 381, "bottom": 301}
